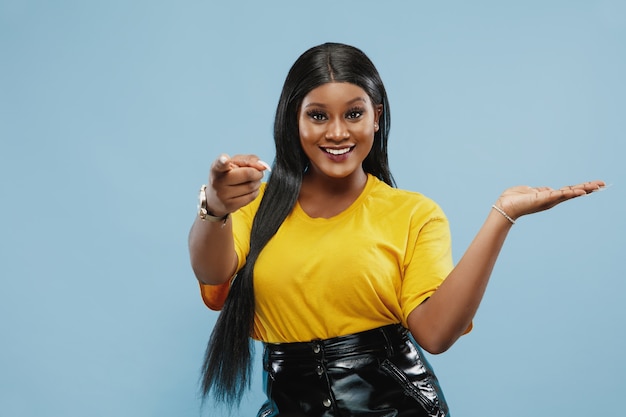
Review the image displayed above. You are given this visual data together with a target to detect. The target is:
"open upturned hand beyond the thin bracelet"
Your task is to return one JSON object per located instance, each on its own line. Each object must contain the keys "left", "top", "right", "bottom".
{"left": 496, "top": 181, "right": 605, "bottom": 220}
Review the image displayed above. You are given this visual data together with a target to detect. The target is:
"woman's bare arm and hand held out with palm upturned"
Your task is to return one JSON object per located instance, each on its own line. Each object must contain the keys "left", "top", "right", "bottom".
{"left": 408, "top": 181, "right": 604, "bottom": 353}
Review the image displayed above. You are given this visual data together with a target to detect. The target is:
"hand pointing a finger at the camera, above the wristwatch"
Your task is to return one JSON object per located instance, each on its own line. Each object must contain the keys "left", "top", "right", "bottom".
{"left": 206, "top": 154, "right": 269, "bottom": 217}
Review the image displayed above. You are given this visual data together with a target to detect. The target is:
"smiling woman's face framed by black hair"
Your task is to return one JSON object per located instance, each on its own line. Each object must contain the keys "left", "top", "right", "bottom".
{"left": 298, "top": 82, "right": 382, "bottom": 182}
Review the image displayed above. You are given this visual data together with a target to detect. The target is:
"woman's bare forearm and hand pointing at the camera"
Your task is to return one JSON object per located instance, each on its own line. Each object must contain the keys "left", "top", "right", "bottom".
{"left": 188, "top": 155, "right": 267, "bottom": 285}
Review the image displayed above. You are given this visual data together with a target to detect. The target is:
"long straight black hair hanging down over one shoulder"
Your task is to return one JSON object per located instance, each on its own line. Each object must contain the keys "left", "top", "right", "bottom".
{"left": 201, "top": 43, "right": 395, "bottom": 405}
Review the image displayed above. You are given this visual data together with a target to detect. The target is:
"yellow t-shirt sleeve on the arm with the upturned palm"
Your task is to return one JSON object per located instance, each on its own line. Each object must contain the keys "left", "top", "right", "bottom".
{"left": 400, "top": 207, "right": 454, "bottom": 323}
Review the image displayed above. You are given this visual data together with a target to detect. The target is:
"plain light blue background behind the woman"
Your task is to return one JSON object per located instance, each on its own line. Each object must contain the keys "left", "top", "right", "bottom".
{"left": 0, "top": 0, "right": 626, "bottom": 417}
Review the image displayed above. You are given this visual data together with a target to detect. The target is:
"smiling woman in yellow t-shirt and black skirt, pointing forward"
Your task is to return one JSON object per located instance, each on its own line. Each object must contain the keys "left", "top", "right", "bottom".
{"left": 189, "top": 43, "right": 604, "bottom": 416}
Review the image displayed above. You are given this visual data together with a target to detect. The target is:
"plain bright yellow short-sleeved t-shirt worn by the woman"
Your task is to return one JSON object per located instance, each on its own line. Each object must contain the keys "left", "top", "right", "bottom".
{"left": 201, "top": 175, "right": 453, "bottom": 343}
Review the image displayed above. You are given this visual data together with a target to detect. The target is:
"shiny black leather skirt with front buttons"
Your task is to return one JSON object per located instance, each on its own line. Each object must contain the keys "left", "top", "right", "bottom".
{"left": 257, "top": 324, "right": 450, "bottom": 417}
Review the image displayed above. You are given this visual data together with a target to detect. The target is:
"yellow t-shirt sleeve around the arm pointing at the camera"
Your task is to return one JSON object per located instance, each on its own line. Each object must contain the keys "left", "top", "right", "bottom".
{"left": 200, "top": 185, "right": 261, "bottom": 311}
